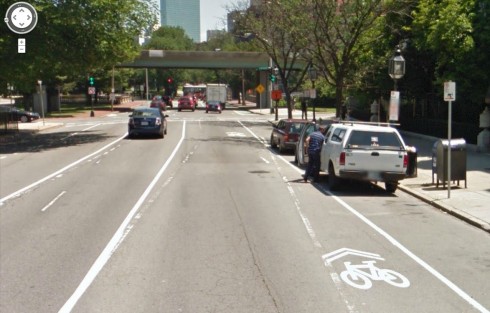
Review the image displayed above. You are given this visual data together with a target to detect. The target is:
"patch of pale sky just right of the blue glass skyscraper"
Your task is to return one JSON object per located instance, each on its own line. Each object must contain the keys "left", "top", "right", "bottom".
{"left": 201, "top": 0, "right": 237, "bottom": 41}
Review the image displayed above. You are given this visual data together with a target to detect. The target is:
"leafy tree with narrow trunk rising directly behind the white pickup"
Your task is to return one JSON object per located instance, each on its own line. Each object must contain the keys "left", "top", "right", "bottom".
{"left": 304, "top": 0, "right": 406, "bottom": 117}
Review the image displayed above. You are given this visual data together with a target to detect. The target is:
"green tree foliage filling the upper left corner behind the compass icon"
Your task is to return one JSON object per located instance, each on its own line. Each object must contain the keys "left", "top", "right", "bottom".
{"left": 0, "top": 0, "right": 156, "bottom": 93}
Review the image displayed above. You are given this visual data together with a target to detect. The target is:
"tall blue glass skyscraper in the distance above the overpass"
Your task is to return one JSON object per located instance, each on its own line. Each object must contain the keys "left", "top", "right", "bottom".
{"left": 160, "top": 0, "right": 201, "bottom": 42}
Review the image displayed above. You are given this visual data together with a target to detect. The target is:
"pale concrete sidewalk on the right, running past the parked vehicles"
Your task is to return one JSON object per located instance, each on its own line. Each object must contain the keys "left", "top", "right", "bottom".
{"left": 241, "top": 103, "right": 490, "bottom": 232}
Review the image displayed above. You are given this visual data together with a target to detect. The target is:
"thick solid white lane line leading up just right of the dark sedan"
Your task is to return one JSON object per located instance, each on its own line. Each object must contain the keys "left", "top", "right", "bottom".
{"left": 58, "top": 121, "right": 186, "bottom": 313}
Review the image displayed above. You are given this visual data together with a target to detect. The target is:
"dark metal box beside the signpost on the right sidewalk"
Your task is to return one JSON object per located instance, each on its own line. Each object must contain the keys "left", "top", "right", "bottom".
{"left": 432, "top": 138, "right": 467, "bottom": 188}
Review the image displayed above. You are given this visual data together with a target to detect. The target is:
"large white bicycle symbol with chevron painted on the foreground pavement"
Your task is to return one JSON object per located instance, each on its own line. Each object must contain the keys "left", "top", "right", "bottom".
{"left": 323, "top": 248, "right": 410, "bottom": 289}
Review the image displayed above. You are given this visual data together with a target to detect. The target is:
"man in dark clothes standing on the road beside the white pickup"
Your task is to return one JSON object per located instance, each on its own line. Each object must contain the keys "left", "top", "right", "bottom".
{"left": 303, "top": 125, "right": 326, "bottom": 183}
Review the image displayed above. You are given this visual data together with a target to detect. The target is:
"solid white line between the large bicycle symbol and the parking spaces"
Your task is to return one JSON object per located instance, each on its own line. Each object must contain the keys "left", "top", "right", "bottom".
{"left": 240, "top": 123, "right": 490, "bottom": 313}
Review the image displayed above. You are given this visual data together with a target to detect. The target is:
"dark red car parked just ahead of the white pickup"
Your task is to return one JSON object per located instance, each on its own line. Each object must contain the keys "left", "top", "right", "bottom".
{"left": 271, "top": 119, "right": 308, "bottom": 153}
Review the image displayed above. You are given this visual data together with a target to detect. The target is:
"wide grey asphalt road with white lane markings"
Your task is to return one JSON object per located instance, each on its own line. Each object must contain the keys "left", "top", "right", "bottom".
{"left": 0, "top": 110, "right": 490, "bottom": 313}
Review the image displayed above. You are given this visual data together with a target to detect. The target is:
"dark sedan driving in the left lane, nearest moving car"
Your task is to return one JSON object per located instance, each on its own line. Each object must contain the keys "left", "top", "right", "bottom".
{"left": 128, "top": 107, "right": 168, "bottom": 138}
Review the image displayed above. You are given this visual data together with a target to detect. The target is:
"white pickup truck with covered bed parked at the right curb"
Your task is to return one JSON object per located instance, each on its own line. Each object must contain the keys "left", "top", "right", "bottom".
{"left": 320, "top": 122, "right": 408, "bottom": 192}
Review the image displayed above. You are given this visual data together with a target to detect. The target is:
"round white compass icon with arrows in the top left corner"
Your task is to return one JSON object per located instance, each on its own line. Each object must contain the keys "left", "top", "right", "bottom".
{"left": 4, "top": 2, "right": 37, "bottom": 35}
